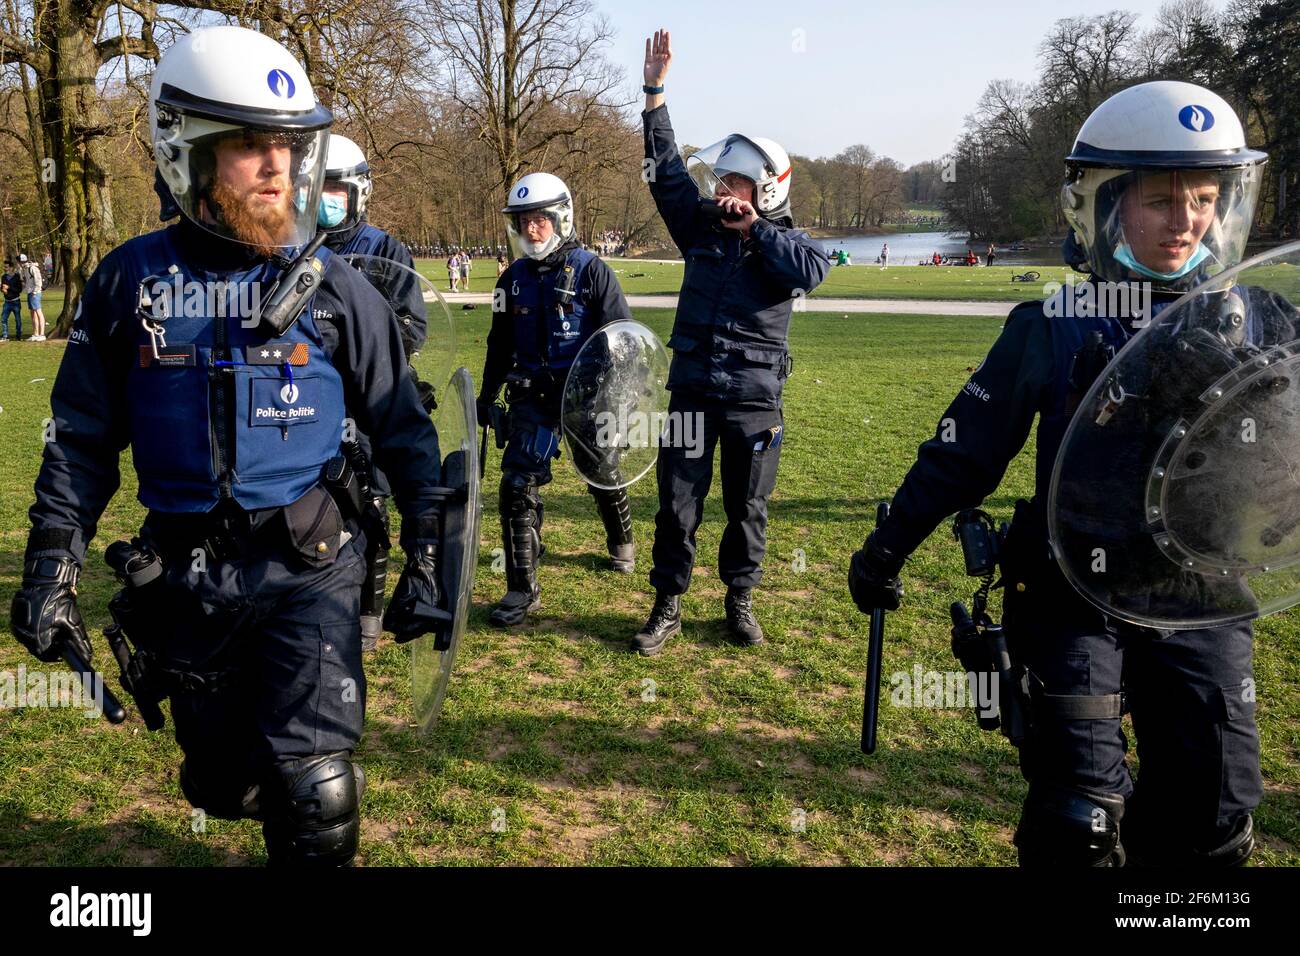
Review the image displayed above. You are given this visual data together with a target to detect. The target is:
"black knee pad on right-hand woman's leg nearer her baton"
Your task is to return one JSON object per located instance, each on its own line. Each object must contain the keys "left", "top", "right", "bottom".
{"left": 1015, "top": 780, "right": 1125, "bottom": 866}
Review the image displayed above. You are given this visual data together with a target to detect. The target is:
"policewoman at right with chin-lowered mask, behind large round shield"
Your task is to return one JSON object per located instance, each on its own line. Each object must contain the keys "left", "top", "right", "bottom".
{"left": 849, "top": 82, "right": 1266, "bottom": 866}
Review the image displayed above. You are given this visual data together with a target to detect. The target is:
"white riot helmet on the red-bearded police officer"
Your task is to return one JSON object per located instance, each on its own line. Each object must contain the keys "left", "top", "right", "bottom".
{"left": 150, "top": 26, "right": 334, "bottom": 247}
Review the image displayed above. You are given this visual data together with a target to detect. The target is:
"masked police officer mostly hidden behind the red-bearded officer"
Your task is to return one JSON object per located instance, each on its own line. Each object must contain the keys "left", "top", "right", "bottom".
{"left": 317, "top": 133, "right": 436, "bottom": 650}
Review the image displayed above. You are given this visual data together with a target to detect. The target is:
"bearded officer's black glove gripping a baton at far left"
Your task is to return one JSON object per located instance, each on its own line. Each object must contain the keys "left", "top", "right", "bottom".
{"left": 9, "top": 557, "right": 92, "bottom": 663}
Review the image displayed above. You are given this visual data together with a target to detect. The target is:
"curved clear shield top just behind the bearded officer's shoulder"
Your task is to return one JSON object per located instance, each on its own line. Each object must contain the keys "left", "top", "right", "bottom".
{"left": 343, "top": 255, "right": 456, "bottom": 401}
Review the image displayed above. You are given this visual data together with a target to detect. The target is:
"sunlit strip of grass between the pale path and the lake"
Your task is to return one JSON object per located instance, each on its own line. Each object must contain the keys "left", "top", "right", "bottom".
{"left": 419, "top": 257, "right": 1071, "bottom": 303}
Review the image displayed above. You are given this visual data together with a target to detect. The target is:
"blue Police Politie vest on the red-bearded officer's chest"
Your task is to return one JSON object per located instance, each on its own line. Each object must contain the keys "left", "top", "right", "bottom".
{"left": 121, "top": 226, "right": 345, "bottom": 512}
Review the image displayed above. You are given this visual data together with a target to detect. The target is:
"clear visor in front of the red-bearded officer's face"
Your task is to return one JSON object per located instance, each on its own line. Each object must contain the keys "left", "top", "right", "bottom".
{"left": 159, "top": 114, "right": 329, "bottom": 250}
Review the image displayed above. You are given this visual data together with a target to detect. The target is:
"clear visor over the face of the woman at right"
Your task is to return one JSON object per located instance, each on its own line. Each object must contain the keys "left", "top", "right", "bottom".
{"left": 1088, "top": 165, "right": 1260, "bottom": 291}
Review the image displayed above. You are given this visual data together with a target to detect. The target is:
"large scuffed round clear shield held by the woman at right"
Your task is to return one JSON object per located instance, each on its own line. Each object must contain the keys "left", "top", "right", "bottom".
{"left": 1048, "top": 243, "right": 1300, "bottom": 630}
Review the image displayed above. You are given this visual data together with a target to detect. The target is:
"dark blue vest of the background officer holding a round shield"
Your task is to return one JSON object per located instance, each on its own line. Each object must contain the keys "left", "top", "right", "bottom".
{"left": 508, "top": 248, "right": 595, "bottom": 372}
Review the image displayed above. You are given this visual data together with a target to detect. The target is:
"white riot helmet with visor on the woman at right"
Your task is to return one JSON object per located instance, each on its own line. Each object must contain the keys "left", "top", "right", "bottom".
{"left": 1061, "top": 79, "right": 1268, "bottom": 291}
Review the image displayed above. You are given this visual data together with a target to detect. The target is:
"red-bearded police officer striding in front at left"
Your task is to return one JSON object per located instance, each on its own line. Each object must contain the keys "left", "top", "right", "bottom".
{"left": 12, "top": 26, "right": 439, "bottom": 865}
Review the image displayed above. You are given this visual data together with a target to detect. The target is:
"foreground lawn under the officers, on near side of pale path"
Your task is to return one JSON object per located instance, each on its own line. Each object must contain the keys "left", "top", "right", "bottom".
{"left": 0, "top": 306, "right": 1300, "bottom": 865}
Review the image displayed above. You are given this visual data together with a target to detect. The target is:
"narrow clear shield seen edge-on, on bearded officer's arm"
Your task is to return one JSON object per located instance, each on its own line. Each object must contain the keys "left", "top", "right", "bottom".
{"left": 411, "top": 368, "right": 480, "bottom": 734}
